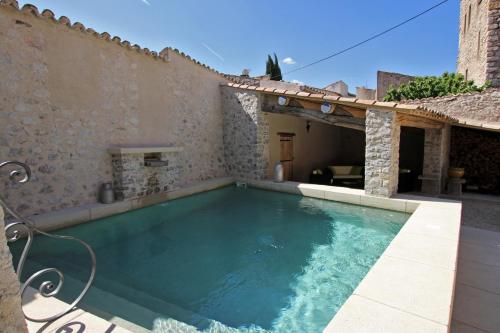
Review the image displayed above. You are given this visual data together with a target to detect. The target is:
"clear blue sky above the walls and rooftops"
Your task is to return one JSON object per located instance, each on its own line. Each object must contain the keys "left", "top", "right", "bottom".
{"left": 20, "top": 0, "right": 459, "bottom": 91}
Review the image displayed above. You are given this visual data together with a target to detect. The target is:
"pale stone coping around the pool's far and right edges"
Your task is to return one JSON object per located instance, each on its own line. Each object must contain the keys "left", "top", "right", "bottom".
{"left": 19, "top": 178, "right": 462, "bottom": 333}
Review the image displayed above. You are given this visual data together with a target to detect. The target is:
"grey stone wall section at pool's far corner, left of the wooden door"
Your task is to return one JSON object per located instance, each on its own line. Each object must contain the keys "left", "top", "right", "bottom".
{"left": 221, "top": 87, "right": 269, "bottom": 179}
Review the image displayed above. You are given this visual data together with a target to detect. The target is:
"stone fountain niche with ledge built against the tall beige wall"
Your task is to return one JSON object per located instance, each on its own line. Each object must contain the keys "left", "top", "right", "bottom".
{"left": 108, "top": 147, "right": 183, "bottom": 200}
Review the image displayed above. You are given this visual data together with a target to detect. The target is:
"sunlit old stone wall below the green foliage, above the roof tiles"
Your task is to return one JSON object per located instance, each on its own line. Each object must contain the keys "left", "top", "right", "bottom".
{"left": 404, "top": 88, "right": 500, "bottom": 123}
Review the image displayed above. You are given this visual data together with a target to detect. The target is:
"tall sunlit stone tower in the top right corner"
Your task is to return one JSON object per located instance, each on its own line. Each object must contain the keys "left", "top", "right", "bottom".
{"left": 457, "top": 0, "right": 500, "bottom": 87}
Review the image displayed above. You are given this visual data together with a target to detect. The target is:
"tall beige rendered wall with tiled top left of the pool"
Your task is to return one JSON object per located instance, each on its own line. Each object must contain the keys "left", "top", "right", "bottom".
{"left": 0, "top": 6, "right": 226, "bottom": 215}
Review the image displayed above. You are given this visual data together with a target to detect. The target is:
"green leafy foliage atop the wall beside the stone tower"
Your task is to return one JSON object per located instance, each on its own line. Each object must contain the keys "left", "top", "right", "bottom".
{"left": 384, "top": 72, "right": 489, "bottom": 102}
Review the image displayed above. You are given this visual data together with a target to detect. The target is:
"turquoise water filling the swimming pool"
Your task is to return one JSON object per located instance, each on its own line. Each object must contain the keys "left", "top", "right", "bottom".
{"left": 13, "top": 186, "right": 408, "bottom": 333}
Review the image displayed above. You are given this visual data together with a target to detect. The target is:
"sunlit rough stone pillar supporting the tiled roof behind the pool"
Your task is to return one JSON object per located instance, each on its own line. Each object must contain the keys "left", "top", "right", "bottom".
{"left": 365, "top": 109, "right": 401, "bottom": 197}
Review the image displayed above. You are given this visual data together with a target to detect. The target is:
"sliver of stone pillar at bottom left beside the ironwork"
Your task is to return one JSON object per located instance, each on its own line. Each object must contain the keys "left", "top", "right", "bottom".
{"left": 0, "top": 207, "right": 28, "bottom": 332}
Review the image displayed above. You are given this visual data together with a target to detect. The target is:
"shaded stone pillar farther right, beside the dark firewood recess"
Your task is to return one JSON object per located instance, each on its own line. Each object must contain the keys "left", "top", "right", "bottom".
{"left": 422, "top": 125, "right": 451, "bottom": 195}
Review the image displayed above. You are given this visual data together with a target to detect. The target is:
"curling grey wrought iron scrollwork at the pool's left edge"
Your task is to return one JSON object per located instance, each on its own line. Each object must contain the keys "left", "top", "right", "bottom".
{"left": 0, "top": 161, "right": 96, "bottom": 322}
